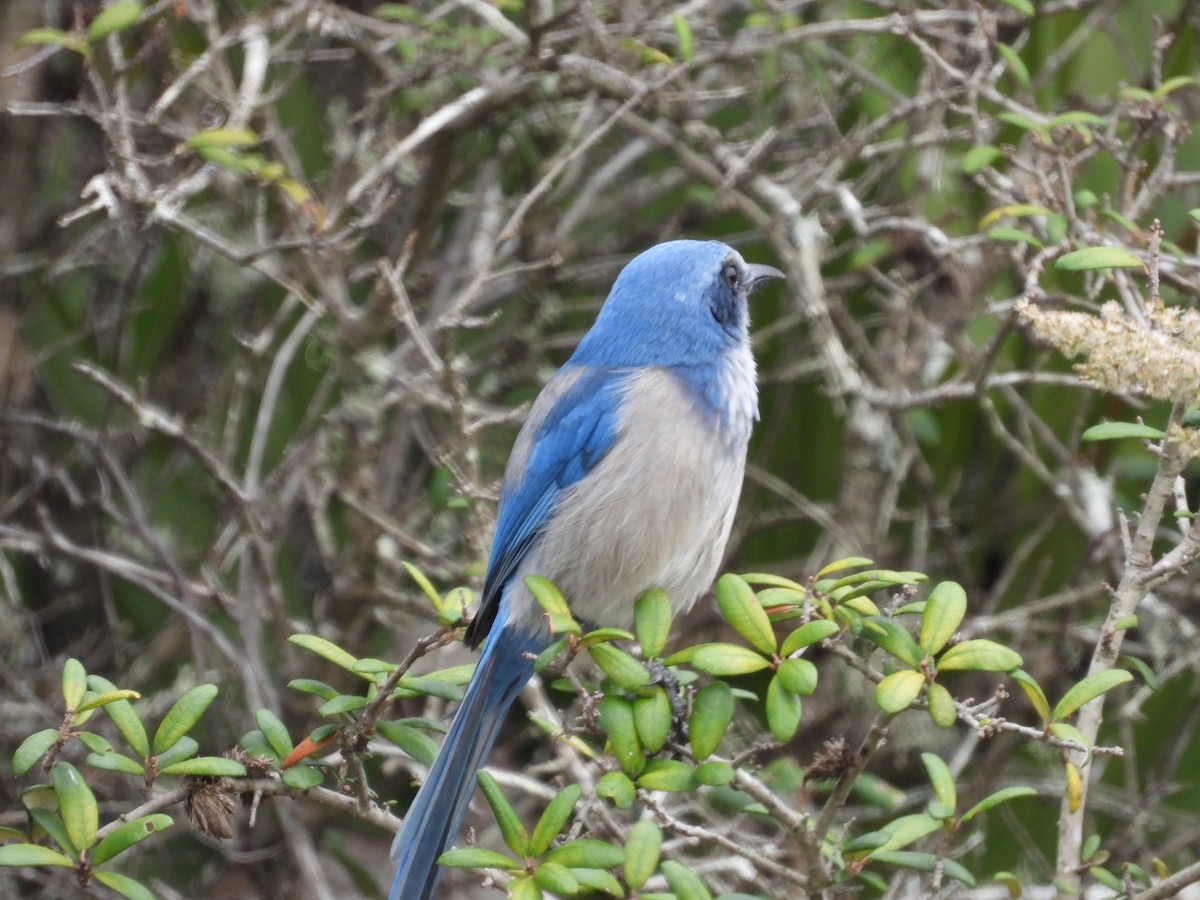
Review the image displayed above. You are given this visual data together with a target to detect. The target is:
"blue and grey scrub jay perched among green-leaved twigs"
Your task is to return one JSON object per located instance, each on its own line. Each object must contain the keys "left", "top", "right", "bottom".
{"left": 389, "top": 240, "right": 784, "bottom": 900}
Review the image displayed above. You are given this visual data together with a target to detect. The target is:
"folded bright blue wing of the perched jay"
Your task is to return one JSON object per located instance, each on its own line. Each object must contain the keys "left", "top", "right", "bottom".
{"left": 467, "top": 366, "right": 629, "bottom": 646}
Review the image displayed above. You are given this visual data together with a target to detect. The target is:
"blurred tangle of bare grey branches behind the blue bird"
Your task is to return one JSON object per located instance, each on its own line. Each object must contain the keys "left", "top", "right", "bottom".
{"left": 0, "top": 0, "right": 1200, "bottom": 896}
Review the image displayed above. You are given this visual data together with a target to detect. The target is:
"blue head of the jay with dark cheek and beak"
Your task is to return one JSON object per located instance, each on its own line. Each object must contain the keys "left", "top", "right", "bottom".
{"left": 568, "top": 241, "right": 782, "bottom": 368}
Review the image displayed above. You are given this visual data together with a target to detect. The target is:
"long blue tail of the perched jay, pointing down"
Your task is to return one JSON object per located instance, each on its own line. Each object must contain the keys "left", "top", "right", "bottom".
{"left": 389, "top": 625, "right": 544, "bottom": 900}
